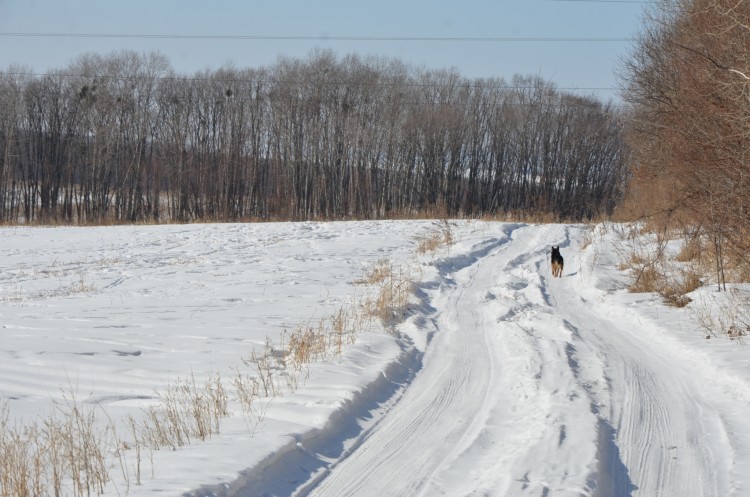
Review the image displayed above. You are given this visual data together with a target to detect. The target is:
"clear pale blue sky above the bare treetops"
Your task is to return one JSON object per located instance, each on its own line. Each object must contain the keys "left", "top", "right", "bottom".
{"left": 0, "top": 0, "right": 646, "bottom": 100}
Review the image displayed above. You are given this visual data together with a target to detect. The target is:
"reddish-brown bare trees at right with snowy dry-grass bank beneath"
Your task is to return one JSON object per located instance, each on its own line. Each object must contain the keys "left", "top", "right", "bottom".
{"left": 615, "top": 0, "right": 750, "bottom": 336}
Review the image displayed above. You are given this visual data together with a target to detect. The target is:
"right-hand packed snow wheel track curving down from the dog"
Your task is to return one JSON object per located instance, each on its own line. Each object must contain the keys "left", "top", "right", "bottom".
{"left": 549, "top": 228, "right": 731, "bottom": 497}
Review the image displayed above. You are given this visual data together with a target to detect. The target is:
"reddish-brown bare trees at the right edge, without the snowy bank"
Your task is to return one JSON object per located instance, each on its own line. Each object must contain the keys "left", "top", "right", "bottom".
{"left": 624, "top": 0, "right": 750, "bottom": 288}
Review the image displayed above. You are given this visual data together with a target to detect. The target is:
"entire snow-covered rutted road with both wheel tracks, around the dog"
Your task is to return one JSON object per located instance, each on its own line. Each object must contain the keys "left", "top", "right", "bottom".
{"left": 222, "top": 225, "right": 748, "bottom": 497}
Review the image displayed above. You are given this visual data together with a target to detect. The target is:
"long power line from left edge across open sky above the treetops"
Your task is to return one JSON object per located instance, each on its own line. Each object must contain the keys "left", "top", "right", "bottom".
{"left": 0, "top": 32, "right": 632, "bottom": 43}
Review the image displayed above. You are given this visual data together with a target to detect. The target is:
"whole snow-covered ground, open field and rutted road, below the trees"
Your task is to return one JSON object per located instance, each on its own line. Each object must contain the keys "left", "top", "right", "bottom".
{"left": 0, "top": 221, "right": 750, "bottom": 497}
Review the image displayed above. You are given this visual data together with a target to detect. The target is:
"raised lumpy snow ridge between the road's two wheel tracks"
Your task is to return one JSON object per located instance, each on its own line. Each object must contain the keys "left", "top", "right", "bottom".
{"left": 447, "top": 225, "right": 597, "bottom": 496}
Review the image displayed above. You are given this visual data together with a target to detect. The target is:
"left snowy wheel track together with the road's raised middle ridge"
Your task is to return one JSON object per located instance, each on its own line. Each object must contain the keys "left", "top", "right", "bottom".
{"left": 310, "top": 227, "right": 597, "bottom": 496}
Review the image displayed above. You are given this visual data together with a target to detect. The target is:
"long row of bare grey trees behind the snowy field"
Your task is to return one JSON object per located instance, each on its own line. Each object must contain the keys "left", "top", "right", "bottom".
{"left": 0, "top": 51, "right": 627, "bottom": 223}
